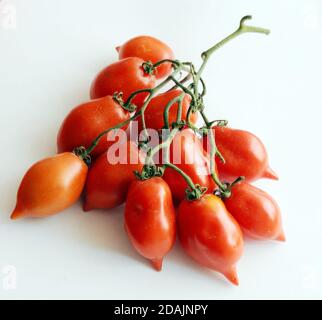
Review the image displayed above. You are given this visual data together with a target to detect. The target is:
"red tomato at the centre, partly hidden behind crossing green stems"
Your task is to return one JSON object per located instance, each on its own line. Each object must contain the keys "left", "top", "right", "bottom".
{"left": 138, "top": 90, "right": 198, "bottom": 130}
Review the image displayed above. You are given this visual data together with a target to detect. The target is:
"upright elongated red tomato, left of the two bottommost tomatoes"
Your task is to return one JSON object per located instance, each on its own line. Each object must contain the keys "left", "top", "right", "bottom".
{"left": 125, "top": 177, "right": 176, "bottom": 271}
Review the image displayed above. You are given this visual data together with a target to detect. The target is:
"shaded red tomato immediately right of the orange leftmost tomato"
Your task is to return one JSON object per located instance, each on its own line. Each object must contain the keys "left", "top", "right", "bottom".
{"left": 84, "top": 141, "right": 144, "bottom": 211}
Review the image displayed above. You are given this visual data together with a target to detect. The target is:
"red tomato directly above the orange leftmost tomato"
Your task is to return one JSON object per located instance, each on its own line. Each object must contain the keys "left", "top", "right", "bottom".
{"left": 57, "top": 96, "right": 130, "bottom": 158}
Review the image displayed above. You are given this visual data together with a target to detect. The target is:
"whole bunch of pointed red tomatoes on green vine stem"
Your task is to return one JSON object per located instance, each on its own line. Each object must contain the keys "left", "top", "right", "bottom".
{"left": 11, "top": 16, "right": 285, "bottom": 284}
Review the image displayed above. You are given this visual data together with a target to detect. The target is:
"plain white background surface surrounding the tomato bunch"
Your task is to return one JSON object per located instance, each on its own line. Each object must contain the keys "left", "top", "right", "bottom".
{"left": 0, "top": 0, "right": 322, "bottom": 299}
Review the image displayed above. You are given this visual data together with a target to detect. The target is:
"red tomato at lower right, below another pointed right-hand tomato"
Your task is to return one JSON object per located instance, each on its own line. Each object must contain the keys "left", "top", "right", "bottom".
{"left": 225, "top": 182, "right": 285, "bottom": 241}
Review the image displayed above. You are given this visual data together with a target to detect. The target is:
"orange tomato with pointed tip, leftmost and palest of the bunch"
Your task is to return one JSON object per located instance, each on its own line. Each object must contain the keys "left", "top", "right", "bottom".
{"left": 11, "top": 152, "right": 87, "bottom": 219}
